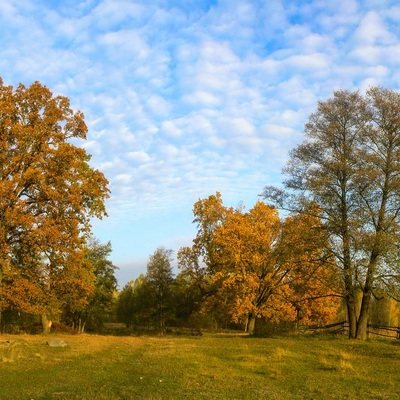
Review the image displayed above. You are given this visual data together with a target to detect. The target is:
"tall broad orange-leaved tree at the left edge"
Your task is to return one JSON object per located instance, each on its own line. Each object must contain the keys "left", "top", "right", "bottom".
{"left": 0, "top": 79, "right": 109, "bottom": 328}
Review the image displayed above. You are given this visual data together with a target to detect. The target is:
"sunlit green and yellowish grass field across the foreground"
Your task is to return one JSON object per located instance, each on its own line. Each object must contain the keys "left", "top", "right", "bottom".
{"left": 0, "top": 334, "right": 400, "bottom": 400}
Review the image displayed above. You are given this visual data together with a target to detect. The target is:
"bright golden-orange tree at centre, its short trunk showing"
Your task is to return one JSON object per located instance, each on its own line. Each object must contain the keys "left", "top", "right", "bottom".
{"left": 178, "top": 192, "right": 291, "bottom": 333}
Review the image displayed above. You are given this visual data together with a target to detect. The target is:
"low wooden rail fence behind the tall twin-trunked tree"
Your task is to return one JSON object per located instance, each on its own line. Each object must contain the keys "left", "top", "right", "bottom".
{"left": 299, "top": 321, "right": 400, "bottom": 339}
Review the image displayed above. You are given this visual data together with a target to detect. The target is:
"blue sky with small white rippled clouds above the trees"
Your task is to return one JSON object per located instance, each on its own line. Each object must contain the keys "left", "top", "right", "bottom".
{"left": 0, "top": 0, "right": 400, "bottom": 287}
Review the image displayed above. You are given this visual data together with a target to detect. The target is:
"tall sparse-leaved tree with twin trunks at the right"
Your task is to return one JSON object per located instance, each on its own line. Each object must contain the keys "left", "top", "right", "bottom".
{"left": 264, "top": 87, "right": 400, "bottom": 339}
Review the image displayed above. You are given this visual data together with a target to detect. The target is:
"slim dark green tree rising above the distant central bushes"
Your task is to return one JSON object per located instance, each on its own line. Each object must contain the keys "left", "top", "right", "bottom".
{"left": 146, "top": 247, "right": 173, "bottom": 334}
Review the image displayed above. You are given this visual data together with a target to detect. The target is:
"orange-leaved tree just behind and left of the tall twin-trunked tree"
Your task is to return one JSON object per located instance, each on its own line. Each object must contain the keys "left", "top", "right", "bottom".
{"left": 279, "top": 211, "right": 343, "bottom": 326}
